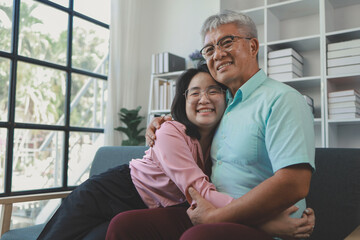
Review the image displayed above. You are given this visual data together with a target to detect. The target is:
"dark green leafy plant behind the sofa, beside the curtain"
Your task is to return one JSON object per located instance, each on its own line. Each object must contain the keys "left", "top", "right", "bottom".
{"left": 115, "top": 106, "right": 145, "bottom": 146}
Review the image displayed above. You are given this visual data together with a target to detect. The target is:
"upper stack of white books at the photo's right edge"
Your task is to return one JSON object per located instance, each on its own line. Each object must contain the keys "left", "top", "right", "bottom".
{"left": 327, "top": 39, "right": 360, "bottom": 75}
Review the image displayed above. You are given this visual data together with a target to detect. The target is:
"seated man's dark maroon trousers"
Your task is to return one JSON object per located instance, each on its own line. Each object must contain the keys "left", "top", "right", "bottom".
{"left": 106, "top": 207, "right": 273, "bottom": 240}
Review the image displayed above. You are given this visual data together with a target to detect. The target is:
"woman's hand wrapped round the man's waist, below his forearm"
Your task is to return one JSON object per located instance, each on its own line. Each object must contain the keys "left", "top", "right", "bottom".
{"left": 258, "top": 206, "right": 315, "bottom": 239}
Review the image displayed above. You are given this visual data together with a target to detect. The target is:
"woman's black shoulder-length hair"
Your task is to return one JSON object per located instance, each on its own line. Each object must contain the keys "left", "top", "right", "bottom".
{"left": 171, "top": 64, "right": 226, "bottom": 139}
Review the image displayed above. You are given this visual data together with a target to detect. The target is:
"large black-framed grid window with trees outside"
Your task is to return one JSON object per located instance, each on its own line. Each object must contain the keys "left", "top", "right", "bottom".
{"left": 0, "top": 0, "right": 110, "bottom": 228}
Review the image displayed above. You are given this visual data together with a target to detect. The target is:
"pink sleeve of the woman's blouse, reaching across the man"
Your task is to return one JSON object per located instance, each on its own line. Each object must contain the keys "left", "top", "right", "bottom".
{"left": 153, "top": 123, "right": 233, "bottom": 207}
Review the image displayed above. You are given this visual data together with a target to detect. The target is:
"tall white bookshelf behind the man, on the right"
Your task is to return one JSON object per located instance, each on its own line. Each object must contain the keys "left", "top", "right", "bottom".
{"left": 220, "top": 0, "right": 360, "bottom": 148}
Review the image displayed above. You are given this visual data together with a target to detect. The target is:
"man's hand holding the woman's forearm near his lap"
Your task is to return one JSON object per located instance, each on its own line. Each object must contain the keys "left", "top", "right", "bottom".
{"left": 187, "top": 187, "right": 217, "bottom": 225}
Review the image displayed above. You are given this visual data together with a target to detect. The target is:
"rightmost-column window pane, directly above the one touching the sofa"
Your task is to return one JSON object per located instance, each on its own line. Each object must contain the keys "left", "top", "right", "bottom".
{"left": 70, "top": 74, "right": 107, "bottom": 128}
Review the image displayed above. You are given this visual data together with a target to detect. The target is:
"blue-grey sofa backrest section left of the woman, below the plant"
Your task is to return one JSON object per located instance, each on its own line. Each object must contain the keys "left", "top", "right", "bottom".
{"left": 90, "top": 146, "right": 149, "bottom": 176}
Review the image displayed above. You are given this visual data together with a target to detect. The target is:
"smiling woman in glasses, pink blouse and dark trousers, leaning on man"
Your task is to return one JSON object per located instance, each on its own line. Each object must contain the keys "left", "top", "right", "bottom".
{"left": 38, "top": 68, "right": 233, "bottom": 240}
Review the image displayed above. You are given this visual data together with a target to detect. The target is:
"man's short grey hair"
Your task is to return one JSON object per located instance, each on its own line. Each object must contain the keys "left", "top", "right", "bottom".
{"left": 201, "top": 10, "right": 257, "bottom": 42}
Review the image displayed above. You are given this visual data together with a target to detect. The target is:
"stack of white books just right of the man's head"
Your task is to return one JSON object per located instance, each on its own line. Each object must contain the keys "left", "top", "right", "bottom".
{"left": 268, "top": 48, "right": 303, "bottom": 81}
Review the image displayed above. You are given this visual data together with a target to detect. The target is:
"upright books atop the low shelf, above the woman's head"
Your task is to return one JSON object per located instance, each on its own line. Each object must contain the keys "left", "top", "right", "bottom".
{"left": 151, "top": 52, "right": 185, "bottom": 74}
